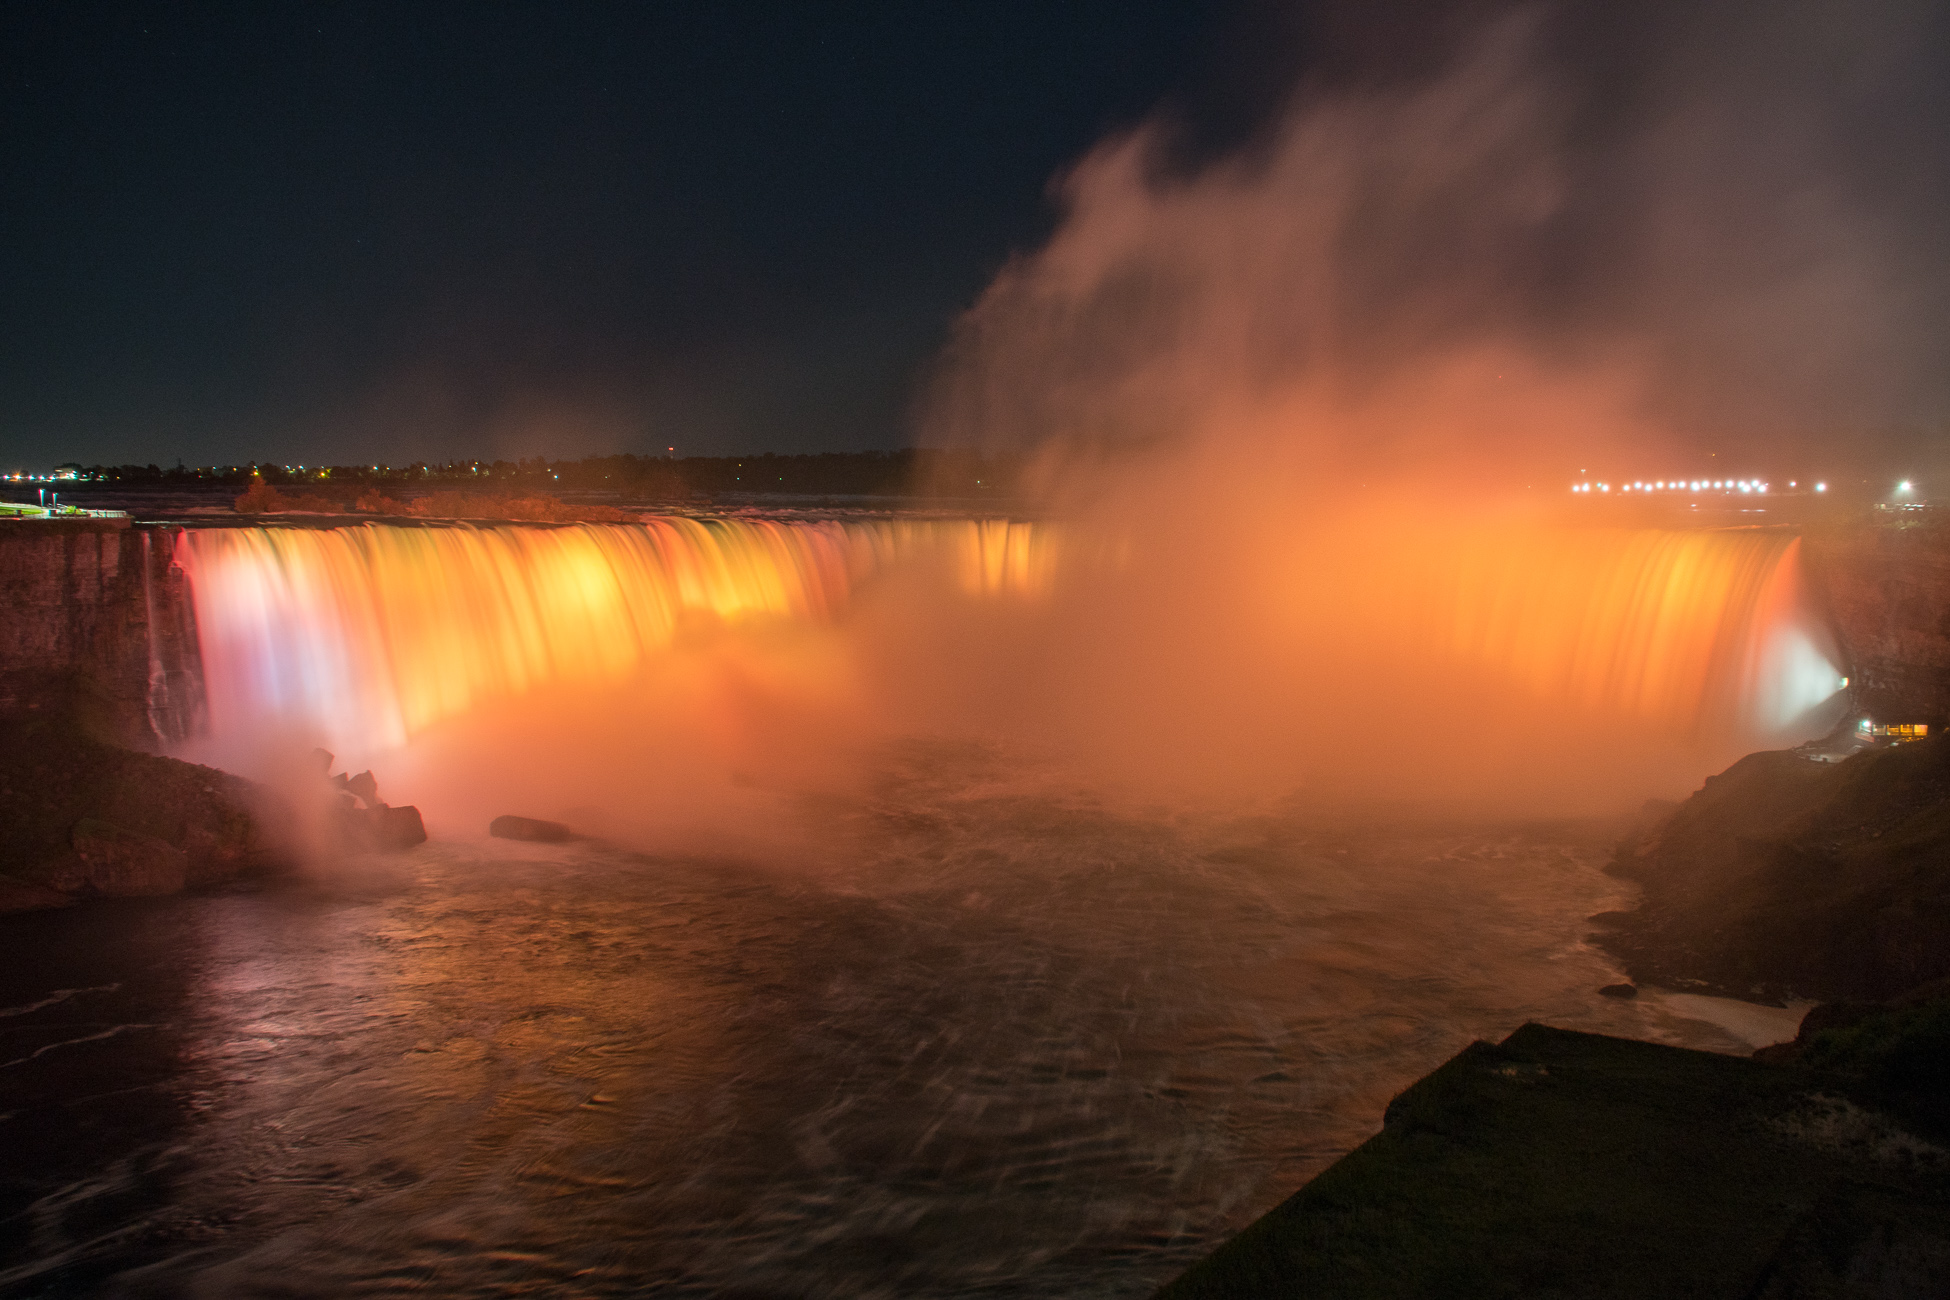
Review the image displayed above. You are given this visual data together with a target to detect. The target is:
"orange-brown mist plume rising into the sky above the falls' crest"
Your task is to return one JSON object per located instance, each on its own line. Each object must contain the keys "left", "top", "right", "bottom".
{"left": 922, "top": 4, "right": 1950, "bottom": 476}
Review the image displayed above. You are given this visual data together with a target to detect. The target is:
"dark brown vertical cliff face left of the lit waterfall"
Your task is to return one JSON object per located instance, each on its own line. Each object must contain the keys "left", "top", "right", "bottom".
{"left": 0, "top": 518, "right": 203, "bottom": 750}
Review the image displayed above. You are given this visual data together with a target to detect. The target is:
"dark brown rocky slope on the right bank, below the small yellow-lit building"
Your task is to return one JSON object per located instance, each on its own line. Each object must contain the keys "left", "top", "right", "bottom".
{"left": 1591, "top": 735, "right": 1950, "bottom": 1002}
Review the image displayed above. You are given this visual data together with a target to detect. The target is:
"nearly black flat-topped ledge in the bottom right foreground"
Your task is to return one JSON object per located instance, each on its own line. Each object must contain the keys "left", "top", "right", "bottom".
{"left": 1156, "top": 1025, "right": 1950, "bottom": 1300}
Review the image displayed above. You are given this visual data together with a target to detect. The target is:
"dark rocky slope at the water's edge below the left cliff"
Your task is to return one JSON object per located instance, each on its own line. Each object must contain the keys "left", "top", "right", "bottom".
{"left": 0, "top": 715, "right": 294, "bottom": 912}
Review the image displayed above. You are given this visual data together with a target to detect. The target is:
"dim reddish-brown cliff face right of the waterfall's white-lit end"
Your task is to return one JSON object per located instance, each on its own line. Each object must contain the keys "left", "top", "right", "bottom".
{"left": 1802, "top": 526, "right": 1950, "bottom": 727}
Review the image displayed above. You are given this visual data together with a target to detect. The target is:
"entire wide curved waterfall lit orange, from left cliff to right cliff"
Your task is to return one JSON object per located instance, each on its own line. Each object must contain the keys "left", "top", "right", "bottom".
{"left": 183, "top": 518, "right": 1841, "bottom": 795}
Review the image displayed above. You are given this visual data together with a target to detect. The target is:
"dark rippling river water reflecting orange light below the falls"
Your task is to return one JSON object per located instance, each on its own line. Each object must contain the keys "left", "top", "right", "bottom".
{"left": 0, "top": 750, "right": 1792, "bottom": 1298}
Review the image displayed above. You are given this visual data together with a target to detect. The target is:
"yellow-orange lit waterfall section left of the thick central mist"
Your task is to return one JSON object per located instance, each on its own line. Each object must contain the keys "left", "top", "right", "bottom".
{"left": 183, "top": 518, "right": 1049, "bottom": 745}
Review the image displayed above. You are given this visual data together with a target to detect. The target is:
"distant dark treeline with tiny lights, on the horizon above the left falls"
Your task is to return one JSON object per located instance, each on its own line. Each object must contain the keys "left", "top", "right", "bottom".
{"left": 76, "top": 448, "right": 1020, "bottom": 501}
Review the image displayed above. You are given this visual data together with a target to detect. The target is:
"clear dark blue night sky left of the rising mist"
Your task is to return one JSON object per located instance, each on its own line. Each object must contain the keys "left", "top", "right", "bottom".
{"left": 0, "top": 0, "right": 1266, "bottom": 468}
